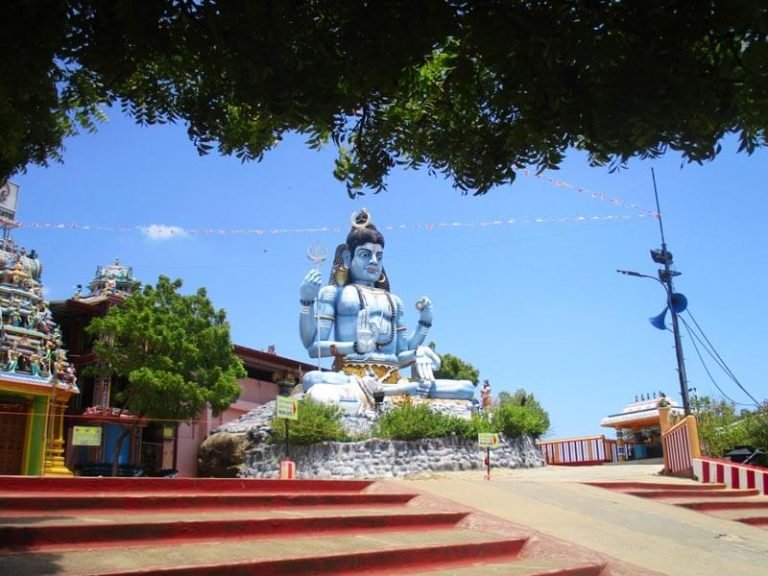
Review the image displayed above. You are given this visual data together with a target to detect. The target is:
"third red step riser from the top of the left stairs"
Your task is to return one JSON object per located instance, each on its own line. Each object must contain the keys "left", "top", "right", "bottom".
{"left": 0, "top": 512, "right": 469, "bottom": 551}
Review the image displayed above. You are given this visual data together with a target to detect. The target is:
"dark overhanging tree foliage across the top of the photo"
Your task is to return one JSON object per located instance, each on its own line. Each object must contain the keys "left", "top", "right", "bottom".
{"left": 0, "top": 0, "right": 768, "bottom": 195}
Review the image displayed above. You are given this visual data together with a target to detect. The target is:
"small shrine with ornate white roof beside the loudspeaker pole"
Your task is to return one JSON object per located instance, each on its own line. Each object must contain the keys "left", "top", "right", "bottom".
{"left": 600, "top": 392, "right": 685, "bottom": 460}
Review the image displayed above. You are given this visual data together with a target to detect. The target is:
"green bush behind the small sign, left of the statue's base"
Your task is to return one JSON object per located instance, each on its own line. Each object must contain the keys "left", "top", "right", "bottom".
{"left": 272, "top": 398, "right": 349, "bottom": 444}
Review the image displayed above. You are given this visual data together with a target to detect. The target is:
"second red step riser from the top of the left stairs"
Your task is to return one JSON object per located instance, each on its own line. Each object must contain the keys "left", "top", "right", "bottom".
{"left": 0, "top": 491, "right": 415, "bottom": 516}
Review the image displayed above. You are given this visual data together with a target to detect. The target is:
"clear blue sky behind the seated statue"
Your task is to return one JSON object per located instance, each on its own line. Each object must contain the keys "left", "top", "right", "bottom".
{"left": 7, "top": 112, "right": 768, "bottom": 438}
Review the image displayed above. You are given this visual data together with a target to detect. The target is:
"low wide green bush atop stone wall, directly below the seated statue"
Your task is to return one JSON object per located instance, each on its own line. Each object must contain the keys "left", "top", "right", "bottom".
{"left": 371, "top": 402, "right": 477, "bottom": 440}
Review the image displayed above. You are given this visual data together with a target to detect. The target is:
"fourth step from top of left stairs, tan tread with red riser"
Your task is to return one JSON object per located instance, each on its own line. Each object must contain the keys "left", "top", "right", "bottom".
{"left": 0, "top": 529, "right": 527, "bottom": 576}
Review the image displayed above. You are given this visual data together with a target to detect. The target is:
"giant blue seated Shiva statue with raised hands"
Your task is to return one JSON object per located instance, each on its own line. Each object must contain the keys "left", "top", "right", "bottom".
{"left": 299, "top": 209, "right": 475, "bottom": 412}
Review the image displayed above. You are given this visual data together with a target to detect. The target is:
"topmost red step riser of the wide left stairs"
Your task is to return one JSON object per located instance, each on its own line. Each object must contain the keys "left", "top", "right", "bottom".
{"left": 0, "top": 476, "right": 373, "bottom": 495}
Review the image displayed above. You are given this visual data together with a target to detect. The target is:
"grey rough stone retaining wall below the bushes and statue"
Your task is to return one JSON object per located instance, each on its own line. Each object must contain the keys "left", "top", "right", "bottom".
{"left": 239, "top": 436, "right": 545, "bottom": 479}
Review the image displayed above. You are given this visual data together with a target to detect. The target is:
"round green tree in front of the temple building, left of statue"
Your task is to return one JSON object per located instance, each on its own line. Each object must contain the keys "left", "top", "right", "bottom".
{"left": 87, "top": 276, "right": 245, "bottom": 421}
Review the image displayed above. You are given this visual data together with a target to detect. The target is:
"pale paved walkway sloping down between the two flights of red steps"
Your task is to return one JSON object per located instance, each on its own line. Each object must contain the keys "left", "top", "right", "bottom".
{"left": 397, "top": 462, "right": 768, "bottom": 576}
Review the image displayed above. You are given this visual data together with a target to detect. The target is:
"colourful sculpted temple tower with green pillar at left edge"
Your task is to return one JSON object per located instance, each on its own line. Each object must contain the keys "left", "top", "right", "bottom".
{"left": 0, "top": 182, "right": 80, "bottom": 476}
